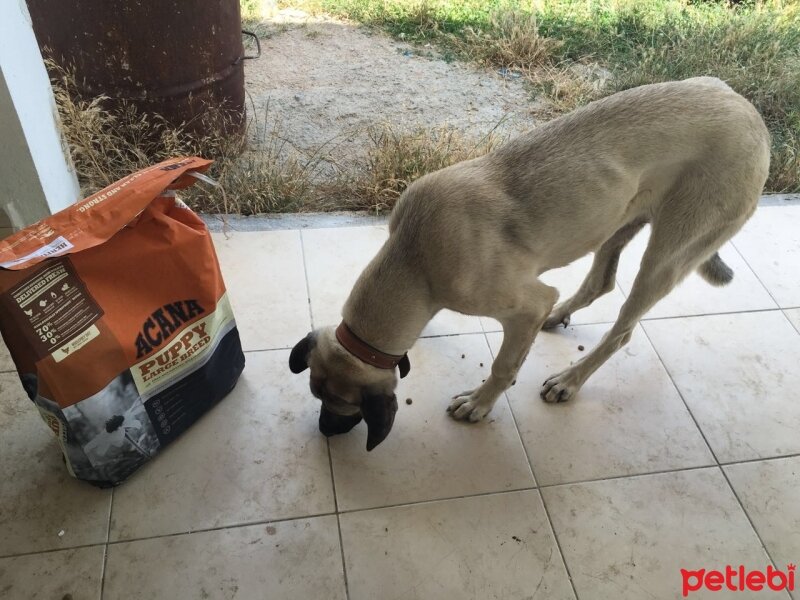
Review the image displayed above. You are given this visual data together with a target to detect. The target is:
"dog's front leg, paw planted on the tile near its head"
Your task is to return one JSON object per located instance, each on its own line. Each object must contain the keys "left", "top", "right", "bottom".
{"left": 447, "top": 279, "right": 558, "bottom": 422}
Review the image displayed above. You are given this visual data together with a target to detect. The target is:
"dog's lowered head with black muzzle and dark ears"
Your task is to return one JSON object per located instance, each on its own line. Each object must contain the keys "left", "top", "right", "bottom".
{"left": 289, "top": 327, "right": 408, "bottom": 451}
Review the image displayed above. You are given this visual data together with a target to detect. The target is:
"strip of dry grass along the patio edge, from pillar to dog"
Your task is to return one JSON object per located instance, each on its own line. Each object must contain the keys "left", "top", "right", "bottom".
{"left": 49, "top": 64, "right": 499, "bottom": 215}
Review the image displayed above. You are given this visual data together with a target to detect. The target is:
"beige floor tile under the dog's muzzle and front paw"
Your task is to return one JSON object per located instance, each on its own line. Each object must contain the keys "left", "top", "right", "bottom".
{"left": 331, "top": 334, "right": 534, "bottom": 510}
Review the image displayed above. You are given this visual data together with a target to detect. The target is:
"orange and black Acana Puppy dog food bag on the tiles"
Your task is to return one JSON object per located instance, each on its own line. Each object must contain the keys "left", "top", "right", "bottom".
{"left": 0, "top": 157, "right": 244, "bottom": 487}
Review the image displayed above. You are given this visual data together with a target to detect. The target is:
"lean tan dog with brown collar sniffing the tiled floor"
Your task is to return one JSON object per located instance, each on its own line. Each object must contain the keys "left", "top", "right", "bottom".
{"left": 289, "top": 77, "right": 770, "bottom": 451}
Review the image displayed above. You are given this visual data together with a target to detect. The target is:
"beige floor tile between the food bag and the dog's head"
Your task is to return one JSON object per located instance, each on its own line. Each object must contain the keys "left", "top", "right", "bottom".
{"left": 111, "top": 350, "right": 334, "bottom": 540}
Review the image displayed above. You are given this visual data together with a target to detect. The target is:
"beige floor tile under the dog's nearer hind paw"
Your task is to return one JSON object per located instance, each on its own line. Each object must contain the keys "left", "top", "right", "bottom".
{"left": 489, "top": 325, "right": 714, "bottom": 485}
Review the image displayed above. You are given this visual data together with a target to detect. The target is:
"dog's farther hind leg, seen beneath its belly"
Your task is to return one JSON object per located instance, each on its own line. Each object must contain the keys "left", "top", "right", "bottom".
{"left": 543, "top": 219, "right": 647, "bottom": 329}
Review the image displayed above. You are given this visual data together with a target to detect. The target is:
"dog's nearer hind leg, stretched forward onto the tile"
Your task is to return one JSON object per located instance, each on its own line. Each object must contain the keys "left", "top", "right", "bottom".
{"left": 541, "top": 211, "right": 744, "bottom": 402}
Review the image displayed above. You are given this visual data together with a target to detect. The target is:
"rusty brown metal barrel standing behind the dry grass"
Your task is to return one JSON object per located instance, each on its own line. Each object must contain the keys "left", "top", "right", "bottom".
{"left": 28, "top": 0, "right": 245, "bottom": 133}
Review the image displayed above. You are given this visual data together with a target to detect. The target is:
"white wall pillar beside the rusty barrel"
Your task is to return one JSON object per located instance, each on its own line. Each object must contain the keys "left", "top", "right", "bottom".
{"left": 0, "top": 0, "right": 80, "bottom": 229}
